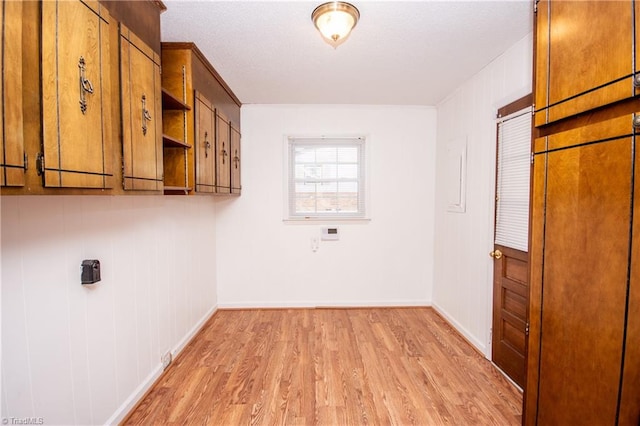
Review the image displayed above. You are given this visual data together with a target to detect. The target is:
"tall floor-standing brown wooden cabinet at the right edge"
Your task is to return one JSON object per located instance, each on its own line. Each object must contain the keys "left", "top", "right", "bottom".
{"left": 524, "top": 0, "right": 640, "bottom": 426}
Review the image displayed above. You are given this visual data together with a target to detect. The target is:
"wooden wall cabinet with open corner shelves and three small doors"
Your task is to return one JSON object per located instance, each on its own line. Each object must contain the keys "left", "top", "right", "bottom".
{"left": 162, "top": 42, "right": 241, "bottom": 194}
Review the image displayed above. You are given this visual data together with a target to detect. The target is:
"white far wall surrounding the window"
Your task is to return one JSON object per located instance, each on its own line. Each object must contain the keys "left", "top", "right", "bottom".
{"left": 216, "top": 105, "right": 436, "bottom": 307}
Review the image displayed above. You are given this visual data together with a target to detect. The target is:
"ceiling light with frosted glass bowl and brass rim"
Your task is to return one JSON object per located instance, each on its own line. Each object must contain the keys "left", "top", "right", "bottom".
{"left": 311, "top": 1, "right": 360, "bottom": 49}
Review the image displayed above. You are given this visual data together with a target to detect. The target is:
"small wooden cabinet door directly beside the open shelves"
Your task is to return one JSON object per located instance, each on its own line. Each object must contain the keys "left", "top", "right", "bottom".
{"left": 195, "top": 92, "right": 216, "bottom": 192}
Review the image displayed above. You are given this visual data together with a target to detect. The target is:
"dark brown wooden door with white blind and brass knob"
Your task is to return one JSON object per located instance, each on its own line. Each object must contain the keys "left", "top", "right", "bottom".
{"left": 491, "top": 95, "right": 532, "bottom": 387}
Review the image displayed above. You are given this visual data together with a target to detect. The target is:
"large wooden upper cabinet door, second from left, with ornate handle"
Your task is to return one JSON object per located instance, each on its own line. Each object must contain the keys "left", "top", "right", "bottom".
{"left": 40, "top": 0, "right": 114, "bottom": 188}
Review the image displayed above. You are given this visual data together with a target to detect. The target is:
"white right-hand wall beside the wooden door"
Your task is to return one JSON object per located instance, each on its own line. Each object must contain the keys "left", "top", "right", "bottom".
{"left": 433, "top": 34, "right": 533, "bottom": 356}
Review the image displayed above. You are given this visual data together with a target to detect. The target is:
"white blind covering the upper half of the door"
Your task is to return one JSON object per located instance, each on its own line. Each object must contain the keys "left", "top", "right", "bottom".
{"left": 495, "top": 107, "right": 532, "bottom": 252}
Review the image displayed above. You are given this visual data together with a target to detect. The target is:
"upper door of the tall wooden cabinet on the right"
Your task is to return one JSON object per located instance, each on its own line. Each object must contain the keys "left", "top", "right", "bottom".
{"left": 535, "top": 0, "right": 639, "bottom": 126}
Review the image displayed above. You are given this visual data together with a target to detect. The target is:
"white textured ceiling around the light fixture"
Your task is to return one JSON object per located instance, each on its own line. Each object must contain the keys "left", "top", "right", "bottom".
{"left": 162, "top": 0, "right": 533, "bottom": 105}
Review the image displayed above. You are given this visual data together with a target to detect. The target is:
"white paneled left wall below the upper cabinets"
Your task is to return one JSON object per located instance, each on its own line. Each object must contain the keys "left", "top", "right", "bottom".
{"left": 1, "top": 196, "right": 217, "bottom": 424}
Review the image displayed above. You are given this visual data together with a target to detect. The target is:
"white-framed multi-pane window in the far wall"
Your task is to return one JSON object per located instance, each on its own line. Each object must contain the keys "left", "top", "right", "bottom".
{"left": 287, "top": 138, "right": 365, "bottom": 219}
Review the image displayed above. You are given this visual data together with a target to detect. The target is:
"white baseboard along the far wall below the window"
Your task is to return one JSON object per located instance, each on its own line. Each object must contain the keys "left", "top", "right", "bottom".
{"left": 218, "top": 299, "right": 431, "bottom": 309}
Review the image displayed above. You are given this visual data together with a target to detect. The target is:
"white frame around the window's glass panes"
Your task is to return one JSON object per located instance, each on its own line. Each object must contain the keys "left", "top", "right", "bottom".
{"left": 283, "top": 136, "right": 370, "bottom": 222}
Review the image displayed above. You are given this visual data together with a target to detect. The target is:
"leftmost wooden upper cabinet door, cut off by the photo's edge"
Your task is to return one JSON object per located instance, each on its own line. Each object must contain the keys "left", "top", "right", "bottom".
{"left": 0, "top": 1, "right": 26, "bottom": 186}
